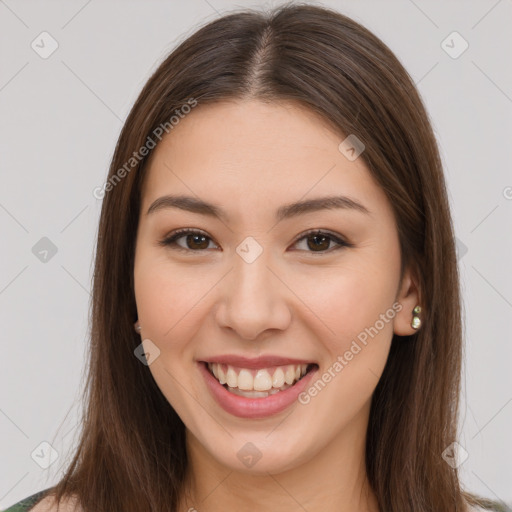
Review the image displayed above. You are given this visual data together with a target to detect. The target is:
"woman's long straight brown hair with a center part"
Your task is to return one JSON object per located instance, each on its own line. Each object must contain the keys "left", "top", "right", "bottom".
{"left": 40, "top": 4, "right": 496, "bottom": 512}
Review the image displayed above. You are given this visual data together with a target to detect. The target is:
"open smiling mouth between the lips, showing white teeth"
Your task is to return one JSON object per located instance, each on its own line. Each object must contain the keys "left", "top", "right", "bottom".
{"left": 204, "top": 362, "right": 318, "bottom": 398}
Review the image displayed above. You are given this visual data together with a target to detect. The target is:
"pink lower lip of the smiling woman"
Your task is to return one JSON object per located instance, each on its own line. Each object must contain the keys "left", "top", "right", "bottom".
{"left": 198, "top": 362, "right": 318, "bottom": 418}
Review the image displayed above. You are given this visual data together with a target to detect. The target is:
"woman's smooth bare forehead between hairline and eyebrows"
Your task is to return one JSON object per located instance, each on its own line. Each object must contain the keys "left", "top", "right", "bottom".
{"left": 138, "top": 100, "right": 386, "bottom": 221}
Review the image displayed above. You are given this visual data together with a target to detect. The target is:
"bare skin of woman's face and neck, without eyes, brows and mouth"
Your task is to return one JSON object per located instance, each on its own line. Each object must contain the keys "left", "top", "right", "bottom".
{"left": 134, "top": 100, "right": 420, "bottom": 512}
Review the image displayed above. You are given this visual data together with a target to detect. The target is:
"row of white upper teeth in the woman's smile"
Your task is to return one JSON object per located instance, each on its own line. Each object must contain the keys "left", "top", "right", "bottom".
{"left": 208, "top": 363, "right": 308, "bottom": 391}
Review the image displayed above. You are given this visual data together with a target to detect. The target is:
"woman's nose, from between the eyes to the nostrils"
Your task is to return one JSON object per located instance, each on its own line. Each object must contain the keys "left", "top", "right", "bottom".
{"left": 216, "top": 247, "right": 292, "bottom": 341}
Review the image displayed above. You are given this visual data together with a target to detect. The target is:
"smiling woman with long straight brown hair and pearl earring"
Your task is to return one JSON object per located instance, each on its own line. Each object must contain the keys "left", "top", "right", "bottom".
{"left": 7, "top": 5, "right": 506, "bottom": 512}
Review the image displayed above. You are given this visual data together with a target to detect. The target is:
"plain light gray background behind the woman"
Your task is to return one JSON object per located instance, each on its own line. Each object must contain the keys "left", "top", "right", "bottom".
{"left": 0, "top": 0, "right": 512, "bottom": 508}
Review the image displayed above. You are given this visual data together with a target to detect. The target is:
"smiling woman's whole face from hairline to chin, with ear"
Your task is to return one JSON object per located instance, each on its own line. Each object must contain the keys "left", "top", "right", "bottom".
{"left": 134, "top": 100, "right": 417, "bottom": 473}
